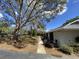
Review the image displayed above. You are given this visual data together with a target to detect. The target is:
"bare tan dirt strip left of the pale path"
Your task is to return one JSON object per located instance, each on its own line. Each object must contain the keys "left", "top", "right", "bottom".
{"left": 0, "top": 43, "right": 37, "bottom": 53}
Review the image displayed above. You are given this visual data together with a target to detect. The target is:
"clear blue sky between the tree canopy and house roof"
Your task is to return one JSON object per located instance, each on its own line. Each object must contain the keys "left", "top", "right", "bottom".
{"left": 46, "top": 0, "right": 79, "bottom": 31}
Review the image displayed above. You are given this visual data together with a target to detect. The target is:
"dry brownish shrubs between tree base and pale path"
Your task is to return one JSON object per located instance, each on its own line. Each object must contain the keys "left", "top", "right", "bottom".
{"left": 8, "top": 35, "right": 37, "bottom": 49}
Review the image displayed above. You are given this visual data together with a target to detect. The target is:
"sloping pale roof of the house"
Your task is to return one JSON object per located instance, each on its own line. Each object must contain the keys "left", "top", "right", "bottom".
{"left": 49, "top": 19, "right": 79, "bottom": 32}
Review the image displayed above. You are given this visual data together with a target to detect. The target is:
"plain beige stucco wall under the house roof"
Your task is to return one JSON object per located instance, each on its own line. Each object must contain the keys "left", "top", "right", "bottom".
{"left": 53, "top": 30, "right": 79, "bottom": 45}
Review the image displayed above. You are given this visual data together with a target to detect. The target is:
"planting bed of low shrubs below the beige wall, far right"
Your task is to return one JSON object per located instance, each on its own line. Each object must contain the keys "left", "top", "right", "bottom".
{"left": 59, "top": 44, "right": 79, "bottom": 55}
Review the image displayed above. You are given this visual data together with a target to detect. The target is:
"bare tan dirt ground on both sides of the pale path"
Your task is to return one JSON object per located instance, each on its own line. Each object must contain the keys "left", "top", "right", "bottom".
{"left": 0, "top": 43, "right": 63, "bottom": 57}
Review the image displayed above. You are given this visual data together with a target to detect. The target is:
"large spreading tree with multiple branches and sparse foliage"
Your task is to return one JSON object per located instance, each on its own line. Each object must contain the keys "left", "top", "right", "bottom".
{"left": 0, "top": 0, "right": 66, "bottom": 40}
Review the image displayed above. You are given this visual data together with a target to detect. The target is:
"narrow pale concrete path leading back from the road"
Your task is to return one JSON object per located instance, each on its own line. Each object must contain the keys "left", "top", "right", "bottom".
{"left": 37, "top": 36, "right": 46, "bottom": 54}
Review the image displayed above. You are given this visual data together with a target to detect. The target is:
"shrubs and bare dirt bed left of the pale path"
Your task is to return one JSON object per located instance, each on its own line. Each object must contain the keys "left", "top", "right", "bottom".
{"left": 0, "top": 36, "right": 37, "bottom": 53}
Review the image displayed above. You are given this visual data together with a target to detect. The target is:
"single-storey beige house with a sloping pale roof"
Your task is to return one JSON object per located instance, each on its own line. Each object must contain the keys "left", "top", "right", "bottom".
{"left": 46, "top": 19, "right": 79, "bottom": 46}
